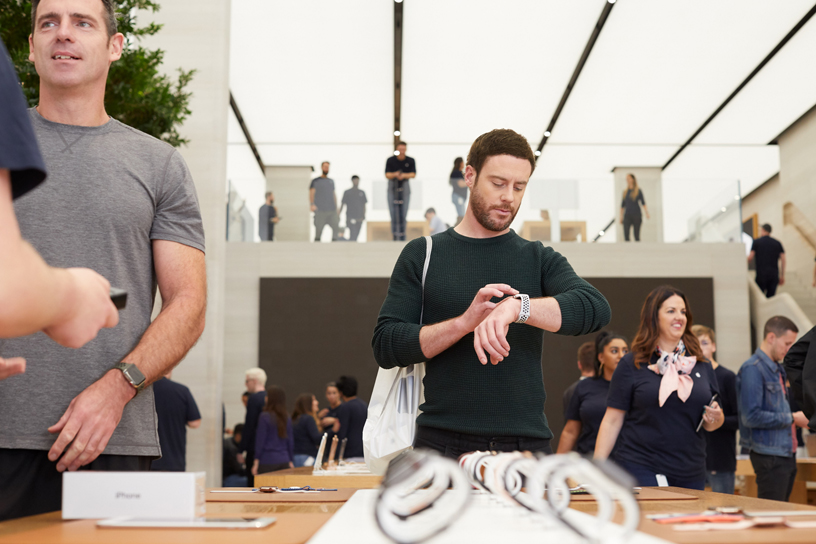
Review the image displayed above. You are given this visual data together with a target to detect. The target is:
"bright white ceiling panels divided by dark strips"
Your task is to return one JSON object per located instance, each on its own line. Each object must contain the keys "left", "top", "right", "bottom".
{"left": 229, "top": 0, "right": 816, "bottom": 240}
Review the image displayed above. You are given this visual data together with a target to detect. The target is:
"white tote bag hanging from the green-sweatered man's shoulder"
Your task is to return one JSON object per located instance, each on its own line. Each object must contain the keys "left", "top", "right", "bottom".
{"left": 363, "top": 236, "right": 433, "bottom": 474}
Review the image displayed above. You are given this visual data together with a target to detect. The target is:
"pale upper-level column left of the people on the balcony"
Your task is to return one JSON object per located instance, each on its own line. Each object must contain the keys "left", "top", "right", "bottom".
{"left": 264, "top": 166, "right": 314, "bottom": 242}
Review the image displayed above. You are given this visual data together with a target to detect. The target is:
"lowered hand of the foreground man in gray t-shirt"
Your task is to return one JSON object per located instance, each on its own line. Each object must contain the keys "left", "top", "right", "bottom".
{"left": 48, "top": 369, "right": 136, "bottom": 472}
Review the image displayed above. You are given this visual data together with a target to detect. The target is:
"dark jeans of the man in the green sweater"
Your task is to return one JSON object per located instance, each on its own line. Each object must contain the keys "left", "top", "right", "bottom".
{"left": 414, "top": 426, "right": 552, "bottom": 459}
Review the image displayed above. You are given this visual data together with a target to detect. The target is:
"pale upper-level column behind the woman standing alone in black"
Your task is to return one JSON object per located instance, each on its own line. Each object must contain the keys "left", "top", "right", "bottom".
{"left": 612, "top": 166, "right": 663, "bottom": 242}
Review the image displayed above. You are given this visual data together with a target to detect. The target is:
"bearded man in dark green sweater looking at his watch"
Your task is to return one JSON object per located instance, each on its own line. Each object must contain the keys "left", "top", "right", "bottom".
{"left": 372, "top": 129, "right": 611, "bottom": 457}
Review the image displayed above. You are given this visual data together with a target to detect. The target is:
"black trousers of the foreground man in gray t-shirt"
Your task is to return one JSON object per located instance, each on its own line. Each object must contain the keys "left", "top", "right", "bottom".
{"left": 0, "top": 449, "right": 153, "bottom": 521}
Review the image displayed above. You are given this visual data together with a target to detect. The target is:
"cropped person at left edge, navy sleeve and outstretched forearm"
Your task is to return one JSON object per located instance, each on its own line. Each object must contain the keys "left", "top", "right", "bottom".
{"left": 0, "top": 40, "right": 119, "bottom": 380}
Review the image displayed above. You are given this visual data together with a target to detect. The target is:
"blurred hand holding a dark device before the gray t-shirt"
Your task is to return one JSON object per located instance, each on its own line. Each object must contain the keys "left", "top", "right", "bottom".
{"left": 43, "top": 268, "right": 119, "bottom": 348}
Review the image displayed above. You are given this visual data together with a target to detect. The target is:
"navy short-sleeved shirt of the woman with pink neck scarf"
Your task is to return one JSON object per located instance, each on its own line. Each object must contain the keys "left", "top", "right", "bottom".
{"left": 606, "top": 352, "right": 720, "bottom": 480}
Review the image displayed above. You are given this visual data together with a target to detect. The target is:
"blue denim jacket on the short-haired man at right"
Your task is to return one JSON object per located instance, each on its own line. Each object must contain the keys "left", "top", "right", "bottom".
{"left": 737, "top": 349, "right": 794, "bottom": 457}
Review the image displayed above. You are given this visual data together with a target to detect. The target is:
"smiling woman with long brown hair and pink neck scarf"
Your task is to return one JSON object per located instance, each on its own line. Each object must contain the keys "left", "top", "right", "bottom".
{"left": 595, "top": 285, "right": 725, "bottom": 491}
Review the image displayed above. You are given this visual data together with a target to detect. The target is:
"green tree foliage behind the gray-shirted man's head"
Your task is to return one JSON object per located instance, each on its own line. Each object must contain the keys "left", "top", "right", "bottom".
{"left": 0, "top": 0, "right": 195, "bottom": 147}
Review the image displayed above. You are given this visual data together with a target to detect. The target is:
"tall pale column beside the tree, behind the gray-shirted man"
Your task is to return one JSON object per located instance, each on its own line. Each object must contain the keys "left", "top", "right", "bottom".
{"left": 138, "top": 0, "right": 230, "bottom": 487}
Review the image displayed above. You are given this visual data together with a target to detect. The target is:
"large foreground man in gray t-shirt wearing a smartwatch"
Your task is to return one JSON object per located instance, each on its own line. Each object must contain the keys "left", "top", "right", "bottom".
{"left": 0, "top": 0, "right": 206, "bottom": 520}
